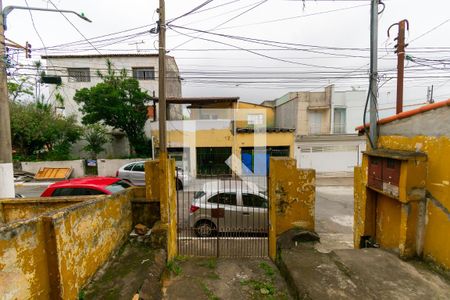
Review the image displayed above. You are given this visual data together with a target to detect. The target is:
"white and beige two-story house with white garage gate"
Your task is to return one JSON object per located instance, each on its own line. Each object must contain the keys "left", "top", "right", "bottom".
{"left": 263, "top": 85, "right": 367, "bottom": 173}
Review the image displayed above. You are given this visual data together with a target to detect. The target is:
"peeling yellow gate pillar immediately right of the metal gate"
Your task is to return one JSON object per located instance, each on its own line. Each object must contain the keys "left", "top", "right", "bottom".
{"left": 269, "top": 157, "right": 316, "bottom": 259}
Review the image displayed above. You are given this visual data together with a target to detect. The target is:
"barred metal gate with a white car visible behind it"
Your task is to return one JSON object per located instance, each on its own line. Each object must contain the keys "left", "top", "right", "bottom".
{"left": 177, "top": 174, "right": 269, "bottom": 257}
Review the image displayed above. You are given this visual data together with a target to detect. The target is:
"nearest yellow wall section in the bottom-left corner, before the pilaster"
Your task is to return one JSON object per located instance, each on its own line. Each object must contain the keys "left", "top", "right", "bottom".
{"left": 0, "top": 218, "right": 50, "bottom": 299}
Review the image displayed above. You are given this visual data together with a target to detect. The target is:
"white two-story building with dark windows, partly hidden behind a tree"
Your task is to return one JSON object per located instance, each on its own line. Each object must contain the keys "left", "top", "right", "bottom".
{"left": 42, "top": 54, "right": 182, "bottom": 157}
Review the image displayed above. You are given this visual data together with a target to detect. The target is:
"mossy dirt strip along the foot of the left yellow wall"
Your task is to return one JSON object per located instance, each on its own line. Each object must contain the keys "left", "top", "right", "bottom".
{"left": 80, "top": 240, "right": 155, "bottom": 299}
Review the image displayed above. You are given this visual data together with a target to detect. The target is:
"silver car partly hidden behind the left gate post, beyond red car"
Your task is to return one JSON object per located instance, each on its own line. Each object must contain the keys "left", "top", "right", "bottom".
{"left": 116, "top": 161, "right": 188, "bottom": 190}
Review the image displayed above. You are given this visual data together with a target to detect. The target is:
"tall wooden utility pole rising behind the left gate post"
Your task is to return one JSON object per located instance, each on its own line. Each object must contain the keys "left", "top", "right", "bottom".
{"left": 158, "top": 0, "right": 167, "bottom": 156}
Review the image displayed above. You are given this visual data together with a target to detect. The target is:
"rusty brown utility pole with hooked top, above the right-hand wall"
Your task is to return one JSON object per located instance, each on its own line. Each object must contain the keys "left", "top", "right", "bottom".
{"left": 388, "top": 20, "right": 409, "bottom": 114}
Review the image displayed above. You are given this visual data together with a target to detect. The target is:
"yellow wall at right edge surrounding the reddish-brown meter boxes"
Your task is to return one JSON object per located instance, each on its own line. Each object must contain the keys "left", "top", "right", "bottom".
{"left": 354, "top": 135, "right": 450, "bottom": 269}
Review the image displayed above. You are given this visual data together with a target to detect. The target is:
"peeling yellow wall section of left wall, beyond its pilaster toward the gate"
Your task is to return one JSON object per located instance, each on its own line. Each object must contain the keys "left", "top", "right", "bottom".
{"left": 52, "top": 191, "right": 132, "bottom": 299}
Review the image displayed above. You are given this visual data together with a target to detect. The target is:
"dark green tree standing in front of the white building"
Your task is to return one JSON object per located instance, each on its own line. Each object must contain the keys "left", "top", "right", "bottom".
{"left": 74, "top": 60, "right": 151, "bottom": 155}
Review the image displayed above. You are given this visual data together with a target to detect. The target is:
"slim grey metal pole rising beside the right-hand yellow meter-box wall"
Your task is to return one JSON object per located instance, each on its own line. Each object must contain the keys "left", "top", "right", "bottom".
{"left": 369, "top": 0, "right": 379, "bottom": 148}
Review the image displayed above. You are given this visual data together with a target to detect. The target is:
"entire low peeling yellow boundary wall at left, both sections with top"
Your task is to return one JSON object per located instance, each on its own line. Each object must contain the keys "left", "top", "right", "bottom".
{"left": 0, "top": 188, "right": 145, "bottom": 299}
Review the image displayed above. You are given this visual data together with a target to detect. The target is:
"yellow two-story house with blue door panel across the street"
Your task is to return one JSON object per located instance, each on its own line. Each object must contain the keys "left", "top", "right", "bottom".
{"left": 151, "top": 97, "right": 294, "bottom": 176}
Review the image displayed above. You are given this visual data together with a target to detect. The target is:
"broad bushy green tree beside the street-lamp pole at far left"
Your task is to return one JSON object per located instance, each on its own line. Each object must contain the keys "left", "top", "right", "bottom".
{"left": 10, "top": 101, "right": 82, "bottom": 160}
